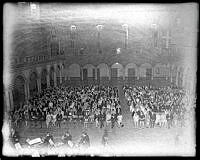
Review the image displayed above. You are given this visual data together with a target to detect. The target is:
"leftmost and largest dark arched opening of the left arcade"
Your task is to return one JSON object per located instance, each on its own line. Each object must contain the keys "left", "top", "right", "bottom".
{"left": 12, "top": 76, "right": 25, "bottom": 108}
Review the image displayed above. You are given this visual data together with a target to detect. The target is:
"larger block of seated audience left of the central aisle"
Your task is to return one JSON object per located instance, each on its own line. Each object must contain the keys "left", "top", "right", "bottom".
{"left": 10, "top": 85, "right": 122, "bottom": 128}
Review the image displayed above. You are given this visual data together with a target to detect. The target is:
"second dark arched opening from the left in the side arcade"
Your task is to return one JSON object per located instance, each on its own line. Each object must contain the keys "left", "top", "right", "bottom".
{"left": 29, "top": 72, "right": 38, "bottom": 97}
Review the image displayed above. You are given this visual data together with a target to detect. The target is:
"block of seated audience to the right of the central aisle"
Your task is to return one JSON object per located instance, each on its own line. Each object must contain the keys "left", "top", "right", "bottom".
{"left": 123, "top": 86, "right": 186, "bottom": 128}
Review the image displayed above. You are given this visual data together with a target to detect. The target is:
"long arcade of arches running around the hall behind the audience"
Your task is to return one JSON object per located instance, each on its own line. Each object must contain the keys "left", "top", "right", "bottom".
{"left": 4, "top": 62, "right": 195, "bottom": 110}
